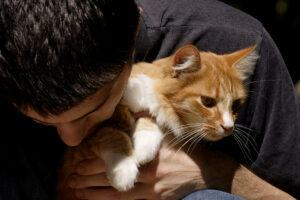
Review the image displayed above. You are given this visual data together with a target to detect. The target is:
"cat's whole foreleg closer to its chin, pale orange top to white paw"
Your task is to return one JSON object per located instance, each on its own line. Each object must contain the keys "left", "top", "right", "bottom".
{"left": 133, "top": 118, "right": 163, "bottom": 164}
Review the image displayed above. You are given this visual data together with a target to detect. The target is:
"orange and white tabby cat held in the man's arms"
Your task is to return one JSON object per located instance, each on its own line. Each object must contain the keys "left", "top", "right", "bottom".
{"left": 59, "top": 45, "right": 258, "bottom": 200}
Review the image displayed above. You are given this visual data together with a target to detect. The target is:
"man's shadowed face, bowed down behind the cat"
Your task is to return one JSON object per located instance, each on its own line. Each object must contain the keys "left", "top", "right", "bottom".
{"left": 21, "top": 64, "right": 131, "bottom": 146}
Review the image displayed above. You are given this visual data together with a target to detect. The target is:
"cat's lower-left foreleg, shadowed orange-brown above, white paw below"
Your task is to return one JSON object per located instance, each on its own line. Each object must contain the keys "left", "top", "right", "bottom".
{"left": 94, "top": 128, "right": 139, "bottom": 191}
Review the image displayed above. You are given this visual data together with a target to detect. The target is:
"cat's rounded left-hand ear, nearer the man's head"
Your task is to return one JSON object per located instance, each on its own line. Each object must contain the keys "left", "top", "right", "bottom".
{"left": 172, "top": 45, "right": 201, "bottom": 77}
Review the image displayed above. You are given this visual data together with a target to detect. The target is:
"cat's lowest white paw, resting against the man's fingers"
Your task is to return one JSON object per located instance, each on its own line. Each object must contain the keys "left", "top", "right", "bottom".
{"left": 107, "top": 157, "right": 139, "bottom": 191}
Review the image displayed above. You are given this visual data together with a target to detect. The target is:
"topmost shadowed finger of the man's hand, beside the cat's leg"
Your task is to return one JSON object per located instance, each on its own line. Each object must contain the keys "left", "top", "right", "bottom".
{"left": 76, "top": 158, "right": 105, "bottom": 175}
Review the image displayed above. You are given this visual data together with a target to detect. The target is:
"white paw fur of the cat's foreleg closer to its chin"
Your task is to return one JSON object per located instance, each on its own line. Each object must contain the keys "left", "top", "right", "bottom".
{"left": 134, "top": 129, "right": 163, "bottom": 164}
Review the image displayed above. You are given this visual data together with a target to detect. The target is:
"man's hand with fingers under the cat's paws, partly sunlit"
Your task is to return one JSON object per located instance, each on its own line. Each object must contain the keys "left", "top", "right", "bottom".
{"left": 70, "top": 147, "right": 204, "bottom": 200}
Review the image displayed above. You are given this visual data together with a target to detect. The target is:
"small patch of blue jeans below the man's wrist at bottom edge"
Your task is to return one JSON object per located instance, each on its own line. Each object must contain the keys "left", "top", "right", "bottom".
{"left": 182, "top": 189, "right": 242, "bottom": 200}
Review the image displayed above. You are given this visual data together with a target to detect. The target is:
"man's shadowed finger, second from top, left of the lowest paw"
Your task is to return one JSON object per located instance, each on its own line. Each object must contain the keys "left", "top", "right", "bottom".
{"left": 69, "top": 173, "right": 110, "bottom": 189}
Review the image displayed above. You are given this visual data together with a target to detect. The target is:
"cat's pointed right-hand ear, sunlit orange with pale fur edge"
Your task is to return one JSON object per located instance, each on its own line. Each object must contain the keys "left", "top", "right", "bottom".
{"left": 226, "top": 44, "right": 259, "bottom": 80}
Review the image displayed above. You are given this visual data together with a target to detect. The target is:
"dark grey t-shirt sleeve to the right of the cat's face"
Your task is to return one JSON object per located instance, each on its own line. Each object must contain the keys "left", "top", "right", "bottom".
{"left": 244, "top": 27, "right": 300, "bottom": 196}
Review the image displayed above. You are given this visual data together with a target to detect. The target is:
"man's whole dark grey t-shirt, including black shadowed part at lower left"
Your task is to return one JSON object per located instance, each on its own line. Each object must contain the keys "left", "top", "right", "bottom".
{"left": 0, "top": 0, "right": 300, "bottom": 200}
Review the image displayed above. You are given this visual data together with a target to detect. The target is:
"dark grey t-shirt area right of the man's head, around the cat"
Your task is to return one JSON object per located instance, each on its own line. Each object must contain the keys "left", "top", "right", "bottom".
{"left": 136, "top": 0, "right": 300, "bottom": 198}
